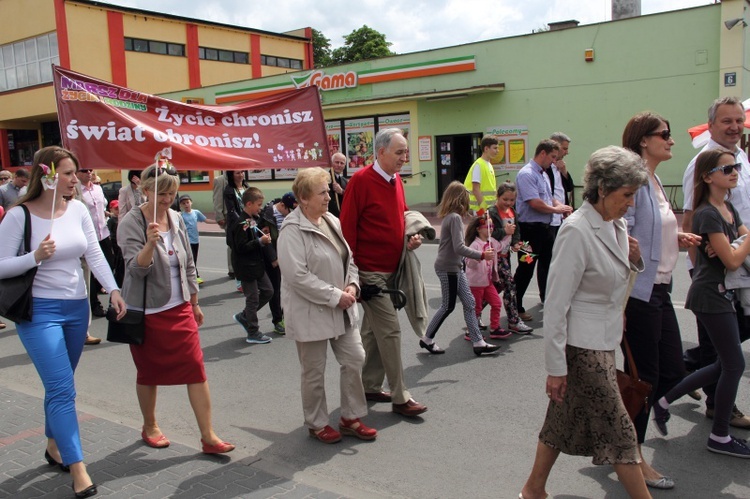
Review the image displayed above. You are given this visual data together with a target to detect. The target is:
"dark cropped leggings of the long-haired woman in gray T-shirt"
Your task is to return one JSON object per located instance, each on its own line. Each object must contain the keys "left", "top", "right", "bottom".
{"left": 668, "top": 312, "right": 745, "bottom": 437}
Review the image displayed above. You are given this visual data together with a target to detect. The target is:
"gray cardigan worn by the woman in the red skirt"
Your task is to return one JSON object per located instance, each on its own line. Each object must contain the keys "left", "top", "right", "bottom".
{"left": 117, "top": 208, "right": 198, "bottom": 308}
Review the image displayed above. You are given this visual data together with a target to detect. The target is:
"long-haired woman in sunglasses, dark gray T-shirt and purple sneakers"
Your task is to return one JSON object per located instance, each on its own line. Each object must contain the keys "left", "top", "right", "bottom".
{"left": 654, "top": 148, "right": 750, "bottom": 458}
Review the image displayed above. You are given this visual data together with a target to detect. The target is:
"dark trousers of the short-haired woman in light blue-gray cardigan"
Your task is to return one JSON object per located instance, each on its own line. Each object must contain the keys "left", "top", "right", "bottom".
{"left": 623, "top": 284, "right": 685, "bottom": 443}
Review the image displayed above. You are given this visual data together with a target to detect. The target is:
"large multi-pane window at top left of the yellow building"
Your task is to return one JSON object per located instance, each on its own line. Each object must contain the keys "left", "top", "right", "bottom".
{"left": 0, "top": 33, "right": 60, "bottom": 92}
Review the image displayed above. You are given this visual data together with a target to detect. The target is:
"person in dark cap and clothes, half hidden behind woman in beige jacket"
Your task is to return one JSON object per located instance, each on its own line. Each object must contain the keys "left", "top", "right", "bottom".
{"left": 258, "top": 192, "right": 297, "bottom": 334}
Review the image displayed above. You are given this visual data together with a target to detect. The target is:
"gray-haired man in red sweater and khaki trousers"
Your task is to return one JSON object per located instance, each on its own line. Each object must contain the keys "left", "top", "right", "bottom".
{"left": 341, "top": 128, "right": 427, "bottom": 416}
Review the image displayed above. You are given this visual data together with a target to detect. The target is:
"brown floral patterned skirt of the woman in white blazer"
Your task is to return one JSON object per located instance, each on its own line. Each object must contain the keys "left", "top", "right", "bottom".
{"left": 539, "top": 345, "right": 641, "bottom": 464}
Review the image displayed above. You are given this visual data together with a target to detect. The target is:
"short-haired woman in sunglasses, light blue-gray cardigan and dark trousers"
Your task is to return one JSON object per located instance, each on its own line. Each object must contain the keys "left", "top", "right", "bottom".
{"left": 622, "top": 112, "right": 700, "bottom": 489}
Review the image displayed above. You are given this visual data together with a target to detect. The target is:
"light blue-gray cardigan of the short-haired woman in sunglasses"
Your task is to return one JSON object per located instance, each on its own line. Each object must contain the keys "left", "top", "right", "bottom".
{"left": 623, "top": 176, "right": 677, "bottom": 302}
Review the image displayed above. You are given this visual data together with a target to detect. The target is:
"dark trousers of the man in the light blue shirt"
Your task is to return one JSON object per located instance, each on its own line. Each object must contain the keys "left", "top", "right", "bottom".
{"left": 513, "top": 222, "right": 555, "bottom": 313}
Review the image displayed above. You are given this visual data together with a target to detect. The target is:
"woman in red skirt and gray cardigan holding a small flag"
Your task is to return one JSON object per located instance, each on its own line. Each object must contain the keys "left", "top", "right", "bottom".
{"left": 117, "top": 165, "right": 234, "bottom": 454}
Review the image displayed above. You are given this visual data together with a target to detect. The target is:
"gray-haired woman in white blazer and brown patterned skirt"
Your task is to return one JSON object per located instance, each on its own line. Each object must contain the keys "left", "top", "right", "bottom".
{"left": 519, "top": 146, "right": 651, "bottom": 499}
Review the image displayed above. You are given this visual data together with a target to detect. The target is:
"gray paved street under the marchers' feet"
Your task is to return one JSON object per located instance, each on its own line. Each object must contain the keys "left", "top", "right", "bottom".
{"left": 0, "top": 237, "right": 750, "bottom": 498}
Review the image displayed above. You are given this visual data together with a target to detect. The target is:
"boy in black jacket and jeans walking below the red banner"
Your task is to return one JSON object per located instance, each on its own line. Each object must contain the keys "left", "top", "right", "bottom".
{"left": 229, "top": 187, "right": 273, "bottom": 343}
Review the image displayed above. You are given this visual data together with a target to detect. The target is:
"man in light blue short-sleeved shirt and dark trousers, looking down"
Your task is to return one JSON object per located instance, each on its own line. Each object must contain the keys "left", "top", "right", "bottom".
{"left": 514, "top": 139, "right": 573, "bottom": 321}
